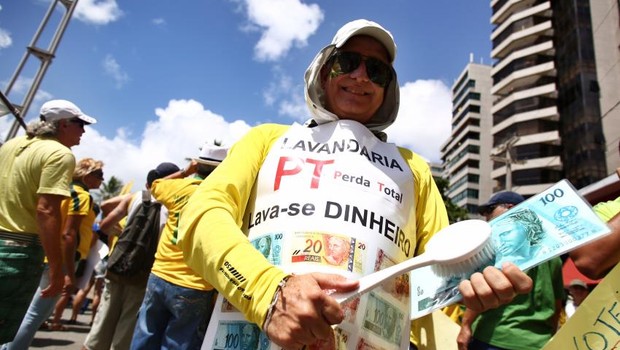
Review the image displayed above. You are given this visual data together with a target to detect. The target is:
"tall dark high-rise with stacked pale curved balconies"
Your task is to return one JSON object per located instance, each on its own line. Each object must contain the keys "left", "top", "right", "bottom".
{"left": 491, "top": 0, "right": 607, "bottom": 196}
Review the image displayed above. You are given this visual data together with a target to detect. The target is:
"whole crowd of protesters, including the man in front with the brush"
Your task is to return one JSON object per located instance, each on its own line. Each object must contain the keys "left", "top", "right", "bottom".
{"left": 0, "top": 20, "right": 620, "bottom": 350}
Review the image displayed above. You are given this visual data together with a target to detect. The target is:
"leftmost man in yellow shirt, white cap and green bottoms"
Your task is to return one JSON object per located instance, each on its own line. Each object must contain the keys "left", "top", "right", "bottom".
{"left": 0, "top": 100, "right": 97, "bottom": 343}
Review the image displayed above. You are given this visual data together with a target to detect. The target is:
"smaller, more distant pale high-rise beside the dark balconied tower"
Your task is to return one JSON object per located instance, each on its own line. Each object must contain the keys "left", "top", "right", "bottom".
{"left": 441, "top": 59, "right": 492, "bottom": 214}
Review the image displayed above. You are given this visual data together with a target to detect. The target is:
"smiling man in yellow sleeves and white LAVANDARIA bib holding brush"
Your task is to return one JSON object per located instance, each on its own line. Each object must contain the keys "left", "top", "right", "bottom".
{"left": 179, "top": 20, "right": 531, "bottom": 349}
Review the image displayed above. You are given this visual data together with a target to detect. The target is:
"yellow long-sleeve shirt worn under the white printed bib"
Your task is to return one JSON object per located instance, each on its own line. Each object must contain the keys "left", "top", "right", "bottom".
{"left": 179, "top": 124, "right": 448, "bottom": 325}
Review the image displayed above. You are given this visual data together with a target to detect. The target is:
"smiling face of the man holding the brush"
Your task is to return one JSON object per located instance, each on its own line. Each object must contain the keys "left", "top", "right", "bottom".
{"left": 321, "top": 36, "right": 389, "bottom": 124}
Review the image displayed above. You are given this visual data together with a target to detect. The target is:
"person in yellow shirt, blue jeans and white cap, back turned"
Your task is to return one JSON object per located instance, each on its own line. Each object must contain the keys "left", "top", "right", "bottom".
{"left": 131, "top": 143, "right": 228, "bottom": 350}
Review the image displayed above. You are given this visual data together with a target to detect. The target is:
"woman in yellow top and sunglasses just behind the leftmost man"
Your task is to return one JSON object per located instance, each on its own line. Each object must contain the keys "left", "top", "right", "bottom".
{"left": 2, "top": 158, "right": 103, "bottom": 350}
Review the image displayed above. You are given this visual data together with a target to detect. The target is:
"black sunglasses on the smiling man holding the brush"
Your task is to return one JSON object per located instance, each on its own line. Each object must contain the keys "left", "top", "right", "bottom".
{"left": 328, "top": 51, "right": 393, "bottom": 88}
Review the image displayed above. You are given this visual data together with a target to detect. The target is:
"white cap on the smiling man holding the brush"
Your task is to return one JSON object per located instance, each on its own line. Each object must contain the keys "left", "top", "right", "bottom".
{"left": 332, "top": 19, "right": 396, "bottom": 63}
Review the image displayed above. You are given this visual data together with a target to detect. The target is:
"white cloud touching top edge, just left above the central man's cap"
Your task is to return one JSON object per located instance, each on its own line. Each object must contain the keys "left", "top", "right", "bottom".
{"left": 245, "top": 0, "right": 324, "bottom": 61}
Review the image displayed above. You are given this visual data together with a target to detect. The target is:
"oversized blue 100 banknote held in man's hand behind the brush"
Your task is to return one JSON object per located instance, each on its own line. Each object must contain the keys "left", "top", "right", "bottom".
{"left": 410, "top": 180, "right": 610, "bottom": 319}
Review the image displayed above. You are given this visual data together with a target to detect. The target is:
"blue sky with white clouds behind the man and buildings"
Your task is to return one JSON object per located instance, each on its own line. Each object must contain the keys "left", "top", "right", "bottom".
{"left": 0, "top": 0, "right": 492, "bottom": 186}
